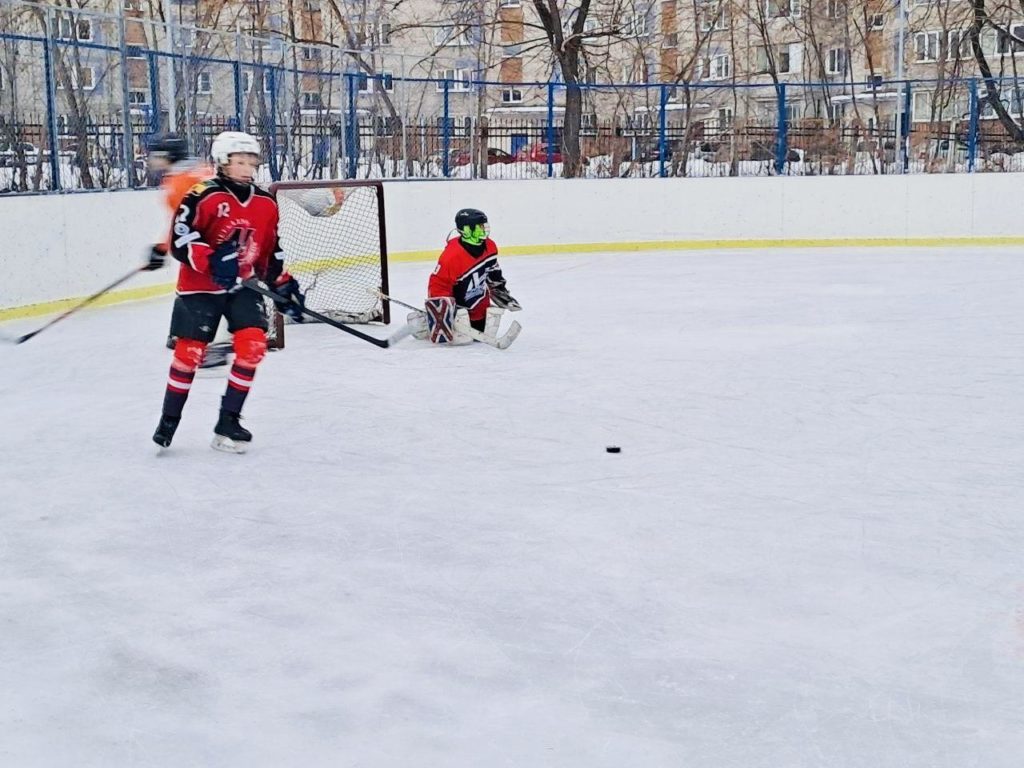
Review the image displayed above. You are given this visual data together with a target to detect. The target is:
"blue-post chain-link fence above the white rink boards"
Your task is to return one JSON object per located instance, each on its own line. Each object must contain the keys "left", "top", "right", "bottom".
{"left": 0, "top": 0, "right": 1024, "bottom": 191}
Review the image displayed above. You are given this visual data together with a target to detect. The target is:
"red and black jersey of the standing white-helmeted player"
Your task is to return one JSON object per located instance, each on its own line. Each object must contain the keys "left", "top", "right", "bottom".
{"left": 171, "top": 177, "right": 285, "bottom": 294}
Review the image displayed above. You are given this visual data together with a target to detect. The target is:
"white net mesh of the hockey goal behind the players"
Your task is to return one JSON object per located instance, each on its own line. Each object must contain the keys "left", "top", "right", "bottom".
{"left": 271, "top": 181, "right": 387, "bottom": 323}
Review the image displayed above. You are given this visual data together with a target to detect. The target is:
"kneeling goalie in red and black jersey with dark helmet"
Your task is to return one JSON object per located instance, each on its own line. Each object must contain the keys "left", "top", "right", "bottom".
{"left": 419, "top": 208, "right": 522, "bottom": 344}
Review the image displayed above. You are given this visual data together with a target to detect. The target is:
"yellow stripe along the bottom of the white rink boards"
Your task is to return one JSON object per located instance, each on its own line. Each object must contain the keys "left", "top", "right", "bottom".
{"left": 0, "top": 237, "right": 1024, "bottom": 322}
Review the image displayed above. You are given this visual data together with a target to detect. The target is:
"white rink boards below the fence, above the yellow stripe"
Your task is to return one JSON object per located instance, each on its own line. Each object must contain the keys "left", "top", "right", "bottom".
{"left": 0, "top": 173, "right": 1024, "bottom": 309}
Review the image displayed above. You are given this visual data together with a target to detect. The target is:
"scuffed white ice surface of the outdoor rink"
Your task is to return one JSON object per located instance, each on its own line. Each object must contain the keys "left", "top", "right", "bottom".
{"left": 0, "top": 249, "right": 1024, "bottom": 768}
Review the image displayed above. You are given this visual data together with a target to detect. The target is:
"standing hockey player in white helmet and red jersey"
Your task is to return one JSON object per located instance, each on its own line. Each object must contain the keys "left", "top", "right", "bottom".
{"left": 153, "top": 131, "right": 303, "bottom": 453}
